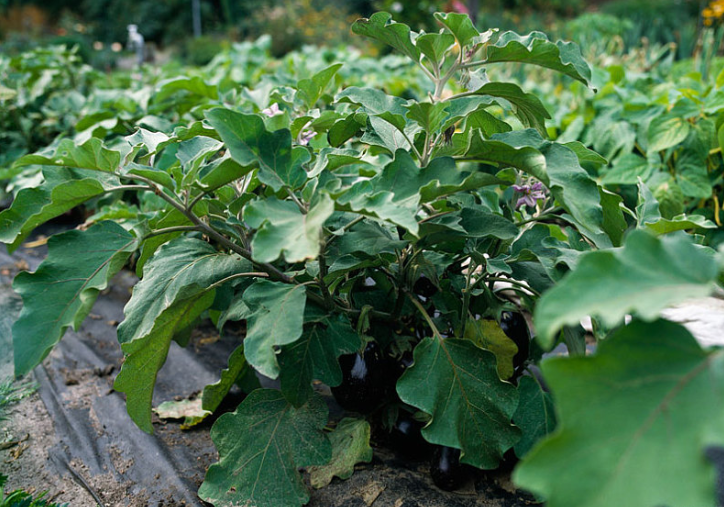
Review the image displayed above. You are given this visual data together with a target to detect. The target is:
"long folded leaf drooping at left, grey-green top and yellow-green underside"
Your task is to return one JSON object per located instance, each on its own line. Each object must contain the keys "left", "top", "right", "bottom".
{"left": 115, "top": 237, "right": 251, "bottom": 433}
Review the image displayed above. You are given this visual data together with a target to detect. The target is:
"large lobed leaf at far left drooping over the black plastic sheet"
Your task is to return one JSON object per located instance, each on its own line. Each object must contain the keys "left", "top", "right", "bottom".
{"left": 13, "top": 222, "right": 136, "bottom": 376}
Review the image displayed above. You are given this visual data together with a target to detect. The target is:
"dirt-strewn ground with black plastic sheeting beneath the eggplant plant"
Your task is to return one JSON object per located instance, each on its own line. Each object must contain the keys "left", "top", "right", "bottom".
{"left": 0, "top": 232, "right": 534, "bottom": 507}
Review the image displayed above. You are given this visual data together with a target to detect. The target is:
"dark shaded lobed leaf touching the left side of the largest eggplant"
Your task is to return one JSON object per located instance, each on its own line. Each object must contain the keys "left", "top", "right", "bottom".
{"left": 278, "top": 315, "right": 362, "bottom": 407}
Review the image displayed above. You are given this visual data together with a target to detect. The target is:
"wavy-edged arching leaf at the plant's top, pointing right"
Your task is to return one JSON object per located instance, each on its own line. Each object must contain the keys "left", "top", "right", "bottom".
{"left": 485, "top": 32, "right": 591, "bottom": 85}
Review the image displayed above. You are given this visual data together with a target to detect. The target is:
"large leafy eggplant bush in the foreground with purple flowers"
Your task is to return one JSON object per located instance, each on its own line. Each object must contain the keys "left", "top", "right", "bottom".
{"left": 0, "top": 13, "right": 724, "bottom": 507}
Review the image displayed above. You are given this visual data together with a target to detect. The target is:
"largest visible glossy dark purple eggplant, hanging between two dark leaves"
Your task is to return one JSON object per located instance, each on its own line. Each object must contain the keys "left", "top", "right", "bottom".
{"left": 332, "top": 342, "right": 396, "bottom": 414}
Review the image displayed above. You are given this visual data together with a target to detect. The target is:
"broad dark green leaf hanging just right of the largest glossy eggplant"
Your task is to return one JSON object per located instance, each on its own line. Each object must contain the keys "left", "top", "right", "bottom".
{"left": 397, "top": 337, "right": 520, "bottom": 469}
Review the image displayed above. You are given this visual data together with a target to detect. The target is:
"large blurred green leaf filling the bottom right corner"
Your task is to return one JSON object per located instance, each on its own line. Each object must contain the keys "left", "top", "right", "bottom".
{"left": 514, "top": 320, "right": 724, "bottom": 507}
